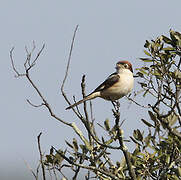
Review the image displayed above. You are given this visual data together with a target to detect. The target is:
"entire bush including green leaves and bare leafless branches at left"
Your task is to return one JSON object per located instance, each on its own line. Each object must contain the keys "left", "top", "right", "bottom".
{"left": 10, "top": 29, "right": 181, "bottom": 180}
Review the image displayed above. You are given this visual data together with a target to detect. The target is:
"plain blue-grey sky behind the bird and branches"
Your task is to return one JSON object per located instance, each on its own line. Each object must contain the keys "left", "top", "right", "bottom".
{"left": 0, "top": 0, "right": 181, "bottom": 180}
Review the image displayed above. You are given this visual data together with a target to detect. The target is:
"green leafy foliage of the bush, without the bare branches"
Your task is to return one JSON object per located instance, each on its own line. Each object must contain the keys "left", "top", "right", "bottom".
{"left": 42, "top": 30, "right": 181, "bottom": 180}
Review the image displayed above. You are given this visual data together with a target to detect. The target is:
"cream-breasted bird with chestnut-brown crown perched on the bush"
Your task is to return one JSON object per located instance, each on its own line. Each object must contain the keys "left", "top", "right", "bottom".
{"left": 66, "top": 60, "right": 134, "bottom": 110}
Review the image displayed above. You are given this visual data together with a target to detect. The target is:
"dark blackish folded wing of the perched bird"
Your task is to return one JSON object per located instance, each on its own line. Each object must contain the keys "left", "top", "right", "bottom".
{"left": 93, "top": 72, "right": 120, "bottom": 92}
